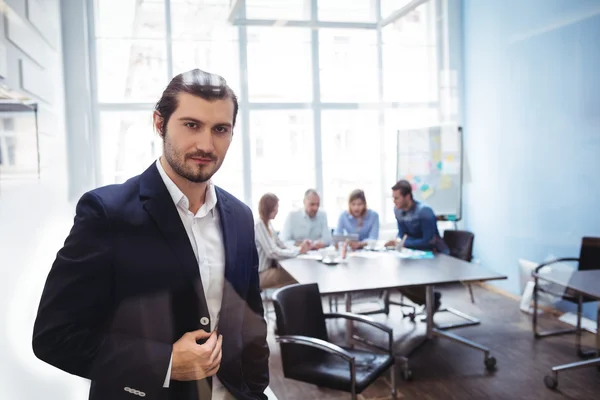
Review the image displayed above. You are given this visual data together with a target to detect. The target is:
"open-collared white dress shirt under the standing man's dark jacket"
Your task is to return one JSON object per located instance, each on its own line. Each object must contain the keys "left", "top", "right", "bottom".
{"left": 156, "top": 159, "right": 228, "bottom": 400}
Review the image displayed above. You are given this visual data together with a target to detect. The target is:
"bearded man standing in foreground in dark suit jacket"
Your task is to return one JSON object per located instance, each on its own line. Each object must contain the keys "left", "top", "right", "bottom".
{"left": 33, "top": 69, "right": 269, "bottom": 400}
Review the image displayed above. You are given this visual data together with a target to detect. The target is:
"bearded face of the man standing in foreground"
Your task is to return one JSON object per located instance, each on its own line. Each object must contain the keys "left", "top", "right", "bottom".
{"left": 154, "top": 93, "right": 234, "bottom": 183}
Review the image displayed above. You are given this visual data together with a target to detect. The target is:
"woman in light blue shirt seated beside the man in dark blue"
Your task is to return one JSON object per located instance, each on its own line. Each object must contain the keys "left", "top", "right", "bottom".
{"left": 334, "top": 189, "right": 379, "bottom": 250}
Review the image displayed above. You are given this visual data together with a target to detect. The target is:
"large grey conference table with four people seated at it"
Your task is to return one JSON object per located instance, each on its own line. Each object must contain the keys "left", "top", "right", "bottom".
{"left": 280, "top": 251, "right": 506, "bottom": 377}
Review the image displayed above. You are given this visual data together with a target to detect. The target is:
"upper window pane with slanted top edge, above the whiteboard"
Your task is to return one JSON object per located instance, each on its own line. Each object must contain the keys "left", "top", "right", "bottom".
{"left": 382, "top": 3, "right": 439, "bottom": 102}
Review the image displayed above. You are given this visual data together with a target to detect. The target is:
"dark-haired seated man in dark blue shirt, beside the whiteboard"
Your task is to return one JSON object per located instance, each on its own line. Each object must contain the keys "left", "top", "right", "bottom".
{"left": 386, "top": 180, "right": 450, "bottom": 310}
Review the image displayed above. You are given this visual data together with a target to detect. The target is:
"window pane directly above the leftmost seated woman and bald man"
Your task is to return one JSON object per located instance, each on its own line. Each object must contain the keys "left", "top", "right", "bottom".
{"left": 250, "top": 110, "right": 315, "bottom": 229}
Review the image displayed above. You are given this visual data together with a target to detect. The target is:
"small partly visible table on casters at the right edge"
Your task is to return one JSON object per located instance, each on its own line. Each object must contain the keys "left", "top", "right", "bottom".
{"left": 533, "top": 270, "right": 600, "bottom": 389}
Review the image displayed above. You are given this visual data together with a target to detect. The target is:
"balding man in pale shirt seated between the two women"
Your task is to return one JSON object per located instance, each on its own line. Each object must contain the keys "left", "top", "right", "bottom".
{"left": 281, "top": 189, "right": 331, "bottom": 250}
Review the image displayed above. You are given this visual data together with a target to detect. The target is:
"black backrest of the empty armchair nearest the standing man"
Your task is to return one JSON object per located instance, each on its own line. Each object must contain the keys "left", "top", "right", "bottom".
{"left": 273, "top": 283, "right": 329, "bottom": 374}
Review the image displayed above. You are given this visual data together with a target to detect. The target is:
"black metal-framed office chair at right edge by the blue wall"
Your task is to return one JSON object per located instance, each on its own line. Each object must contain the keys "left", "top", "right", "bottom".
{"left": 533, "top": 237, "right": 600, "bottom": 357}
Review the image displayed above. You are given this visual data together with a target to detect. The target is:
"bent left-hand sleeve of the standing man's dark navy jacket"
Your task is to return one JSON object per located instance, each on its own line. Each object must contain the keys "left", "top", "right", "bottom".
{"left": 33, "top": 193, "right": 172, "bottom": 393}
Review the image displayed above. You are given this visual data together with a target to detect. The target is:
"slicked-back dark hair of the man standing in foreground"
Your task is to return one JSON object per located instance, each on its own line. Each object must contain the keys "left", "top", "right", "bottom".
{"left": 154, "top": 68, "right": 238, "bottom": 129}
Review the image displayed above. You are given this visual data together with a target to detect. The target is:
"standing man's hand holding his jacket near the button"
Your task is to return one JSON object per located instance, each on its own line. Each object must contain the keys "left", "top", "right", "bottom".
{"left": 171, "top": 329, "right": 223, "bottom": 381}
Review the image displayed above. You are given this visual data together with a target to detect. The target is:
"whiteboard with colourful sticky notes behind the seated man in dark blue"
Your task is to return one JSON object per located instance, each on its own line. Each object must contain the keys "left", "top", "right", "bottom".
{"left": 396, "top": 124, "right": 463, "bottom": 221}
